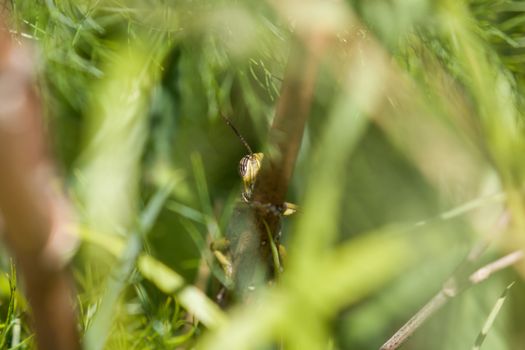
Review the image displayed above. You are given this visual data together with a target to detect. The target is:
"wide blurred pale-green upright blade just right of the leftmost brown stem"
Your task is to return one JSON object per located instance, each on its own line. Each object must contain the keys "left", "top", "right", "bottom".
{"left": 76, "top": 47, "right": 152, "bottom": 235}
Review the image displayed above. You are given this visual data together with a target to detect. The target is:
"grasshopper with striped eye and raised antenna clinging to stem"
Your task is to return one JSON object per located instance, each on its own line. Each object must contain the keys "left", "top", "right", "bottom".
{"left": 210, "top": 113, "right": 297, "bottom": 300}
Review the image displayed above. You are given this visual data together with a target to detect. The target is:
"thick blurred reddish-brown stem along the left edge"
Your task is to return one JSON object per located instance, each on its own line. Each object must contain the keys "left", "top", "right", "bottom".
{"left": 0, "top": 18, "right": 80, "bottom": 350}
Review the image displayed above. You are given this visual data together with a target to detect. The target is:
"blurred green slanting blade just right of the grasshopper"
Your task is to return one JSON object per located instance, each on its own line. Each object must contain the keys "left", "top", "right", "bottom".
{"left": 290, "top": 98, "right": 368, "bottom": 271}
